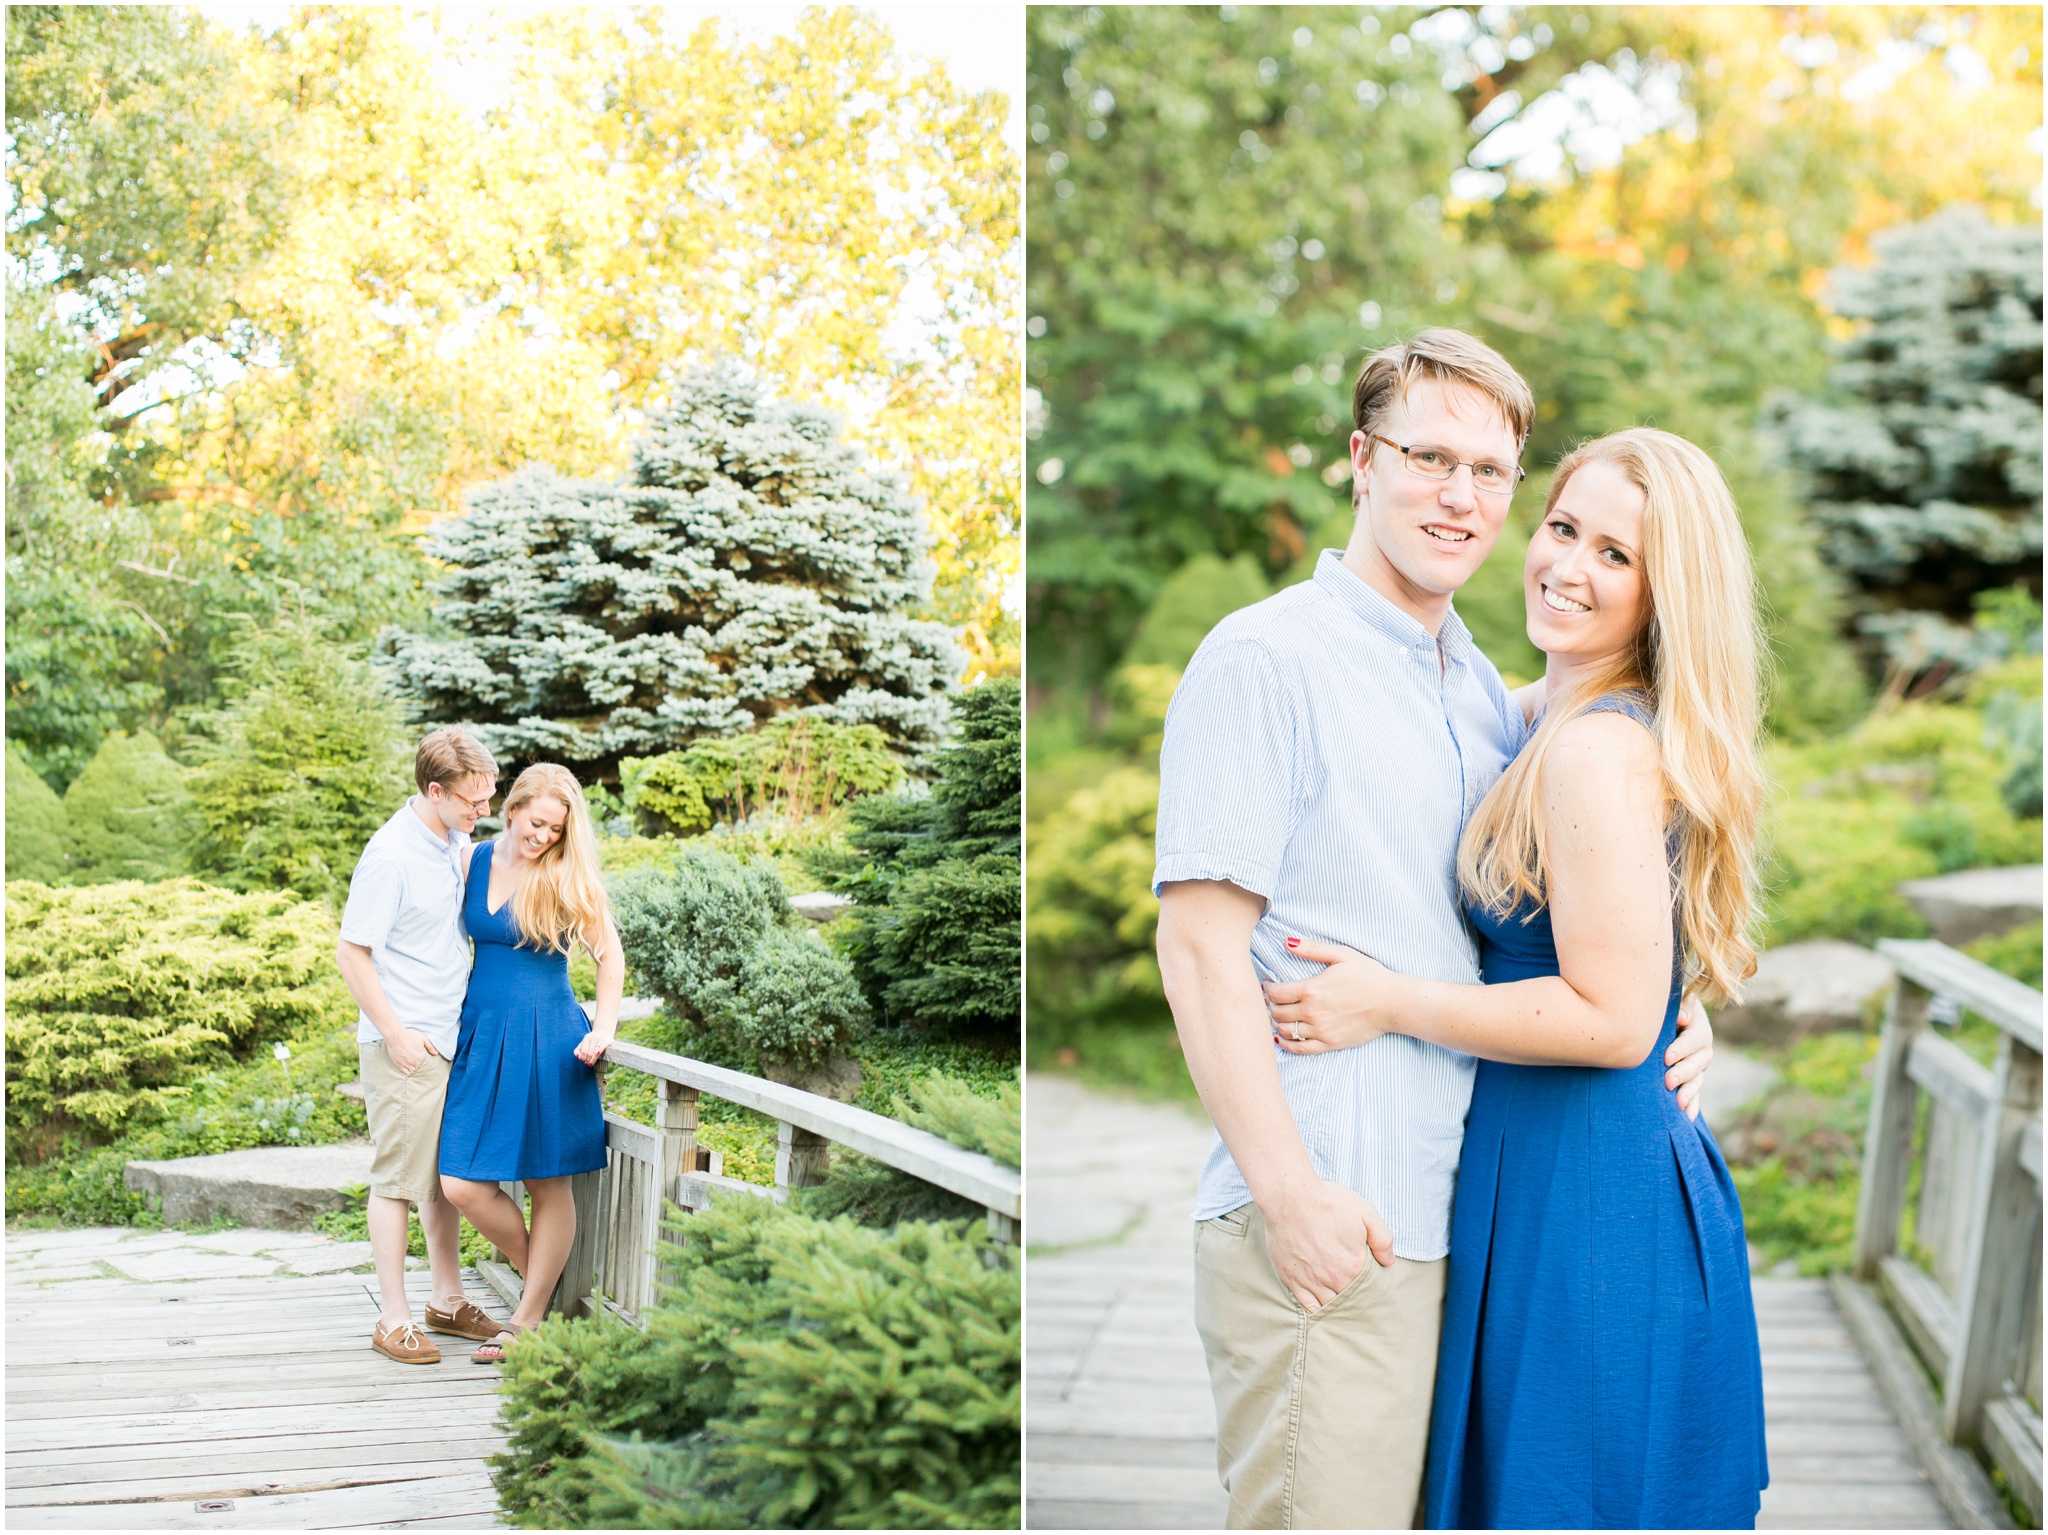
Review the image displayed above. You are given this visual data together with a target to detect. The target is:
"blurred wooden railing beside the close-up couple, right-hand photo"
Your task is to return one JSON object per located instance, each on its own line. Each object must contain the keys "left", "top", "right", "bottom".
{"left": 1855, "top": 939, "right": 2042, "bottom": 1523}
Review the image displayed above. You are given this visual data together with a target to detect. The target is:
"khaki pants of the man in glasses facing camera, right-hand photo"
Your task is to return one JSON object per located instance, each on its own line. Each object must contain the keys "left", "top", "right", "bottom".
{"left": 1194, "top": 1205, "right": 1450, "bottom": 1529}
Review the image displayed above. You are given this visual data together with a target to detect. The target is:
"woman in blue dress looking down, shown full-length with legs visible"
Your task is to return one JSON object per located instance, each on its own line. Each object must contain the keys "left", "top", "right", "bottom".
{"left": 440, "top": 763, "right": 625, "bottom": 1363}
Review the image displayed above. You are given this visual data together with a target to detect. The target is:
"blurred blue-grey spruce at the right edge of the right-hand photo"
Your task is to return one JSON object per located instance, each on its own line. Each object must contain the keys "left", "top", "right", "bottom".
{"left": 1776, "top": 207, "right": 2042, "bottom": 671}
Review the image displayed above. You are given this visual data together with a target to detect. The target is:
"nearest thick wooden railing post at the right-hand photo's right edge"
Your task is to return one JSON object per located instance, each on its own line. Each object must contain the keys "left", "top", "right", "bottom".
{"left": 1942, "top": 1034, "right": 2042, "bottom": 1443}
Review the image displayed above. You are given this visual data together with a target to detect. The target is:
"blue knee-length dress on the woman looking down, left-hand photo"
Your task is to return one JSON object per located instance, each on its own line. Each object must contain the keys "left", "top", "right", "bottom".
{"left": 440, "top": 841, "right": 604, "bottom": 1183}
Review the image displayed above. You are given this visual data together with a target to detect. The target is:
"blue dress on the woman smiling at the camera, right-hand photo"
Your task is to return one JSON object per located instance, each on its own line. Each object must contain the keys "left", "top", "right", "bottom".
{"left": 1423, "top": 696, "right": 1769, "bottom": 1529}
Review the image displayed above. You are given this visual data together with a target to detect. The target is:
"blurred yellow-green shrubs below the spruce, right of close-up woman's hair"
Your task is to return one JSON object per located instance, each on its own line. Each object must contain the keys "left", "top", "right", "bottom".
{"left": 1765, "top": 657, "right": 2042, "bottom": 944}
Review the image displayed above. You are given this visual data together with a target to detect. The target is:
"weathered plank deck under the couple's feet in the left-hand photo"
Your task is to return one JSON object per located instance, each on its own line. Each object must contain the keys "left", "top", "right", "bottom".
{"left": 6, "top": 1273, "right": 504, "bottom": 1531}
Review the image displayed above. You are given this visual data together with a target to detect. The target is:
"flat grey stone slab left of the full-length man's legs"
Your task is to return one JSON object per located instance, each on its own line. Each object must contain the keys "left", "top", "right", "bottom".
{"left": 121, "top": 1140, "right": 371, "bottom": 1230}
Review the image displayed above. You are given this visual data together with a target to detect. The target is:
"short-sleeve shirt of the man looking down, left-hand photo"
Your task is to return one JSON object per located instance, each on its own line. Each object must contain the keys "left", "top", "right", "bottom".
{"left": 342, "top": 800, "right": 469, "bottom": 1060}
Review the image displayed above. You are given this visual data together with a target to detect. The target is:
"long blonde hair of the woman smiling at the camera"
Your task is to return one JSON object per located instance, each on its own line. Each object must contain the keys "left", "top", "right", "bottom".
{"left": 1458, "top": 426, "right": 1763, "bottom": 999}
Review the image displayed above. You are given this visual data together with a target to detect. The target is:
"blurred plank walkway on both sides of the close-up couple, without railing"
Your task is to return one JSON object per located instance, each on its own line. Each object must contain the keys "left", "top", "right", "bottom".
{"left": 1024, "top": 1077, "right": 1952, "bottom": 1529}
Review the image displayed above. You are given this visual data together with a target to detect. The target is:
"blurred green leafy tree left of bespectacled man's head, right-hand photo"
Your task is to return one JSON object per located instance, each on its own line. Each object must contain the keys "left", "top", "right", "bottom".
{"left": 1026, "top": 6, "right": 1470, "bottom": 682}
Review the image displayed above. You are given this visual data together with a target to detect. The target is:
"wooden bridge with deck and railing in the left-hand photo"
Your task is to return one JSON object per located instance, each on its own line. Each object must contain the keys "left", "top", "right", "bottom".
{"left": 6, "top": 1044, "right": 1022, "bottom": 1531}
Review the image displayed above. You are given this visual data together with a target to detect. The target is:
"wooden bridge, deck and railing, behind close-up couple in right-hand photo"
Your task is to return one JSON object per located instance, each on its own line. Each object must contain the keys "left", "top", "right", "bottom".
{"left": 1024, "top": 944, "right": 2042, "bottom": 1529}
